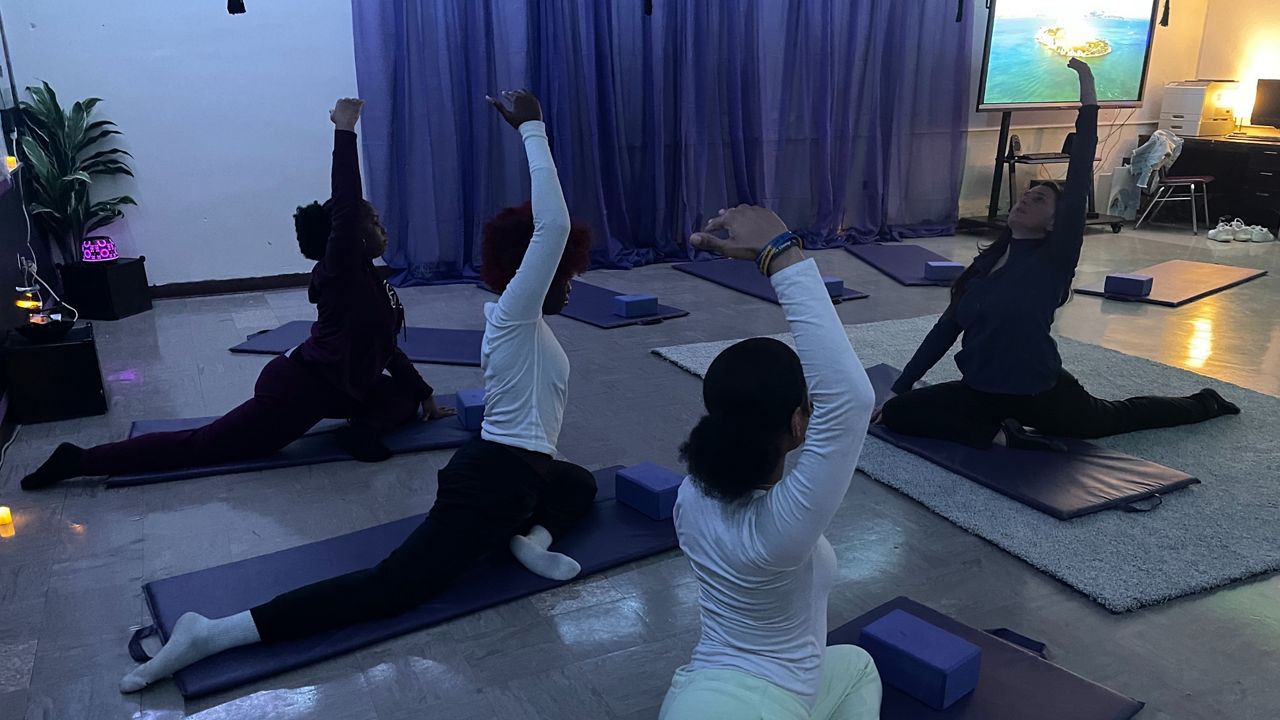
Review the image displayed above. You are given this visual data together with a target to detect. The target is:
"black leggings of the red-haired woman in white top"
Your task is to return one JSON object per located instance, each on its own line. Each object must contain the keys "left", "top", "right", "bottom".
{"left": 252, "top": 439, "right": 595, "bottom": 642}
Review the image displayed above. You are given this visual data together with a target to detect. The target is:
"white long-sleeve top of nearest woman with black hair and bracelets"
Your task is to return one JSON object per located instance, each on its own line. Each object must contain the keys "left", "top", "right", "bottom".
{"left": 675, "top": 260, "right": 876, "bottom": 708}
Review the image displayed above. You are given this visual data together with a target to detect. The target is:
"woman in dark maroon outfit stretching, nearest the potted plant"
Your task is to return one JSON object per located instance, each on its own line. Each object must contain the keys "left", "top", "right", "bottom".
{"left": 22, "top": 99, "right": 454, "bottom": 489}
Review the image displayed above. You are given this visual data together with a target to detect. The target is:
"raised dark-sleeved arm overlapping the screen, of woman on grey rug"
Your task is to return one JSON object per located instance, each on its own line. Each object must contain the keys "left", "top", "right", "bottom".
{"left": 1051, "top": 58, "right": 1098, "bottom": 265}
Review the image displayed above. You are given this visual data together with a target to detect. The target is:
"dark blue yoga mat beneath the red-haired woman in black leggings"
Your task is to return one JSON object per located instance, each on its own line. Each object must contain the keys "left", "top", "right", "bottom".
{"left": 140, "top": 466, "right": 677, "bottom": 698}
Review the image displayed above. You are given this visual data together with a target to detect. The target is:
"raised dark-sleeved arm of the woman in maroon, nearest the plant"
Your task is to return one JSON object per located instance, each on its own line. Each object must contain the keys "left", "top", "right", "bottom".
{"left": 320, "top": 97, "right": 365, "bottom": 274}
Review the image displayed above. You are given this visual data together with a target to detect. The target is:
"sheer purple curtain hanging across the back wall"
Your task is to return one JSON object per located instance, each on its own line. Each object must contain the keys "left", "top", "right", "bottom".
{"left": 353, "top": 0, "right": 973, "bottom": 284}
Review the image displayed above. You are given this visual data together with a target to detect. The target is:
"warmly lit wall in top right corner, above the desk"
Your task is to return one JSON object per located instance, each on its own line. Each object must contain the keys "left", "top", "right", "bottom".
{"left": 1199, "top": 0, "right": 1280, "bottom": 123}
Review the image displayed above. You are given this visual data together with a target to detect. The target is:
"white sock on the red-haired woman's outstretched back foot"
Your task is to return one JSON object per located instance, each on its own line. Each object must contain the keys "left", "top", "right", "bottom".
{"left": 120, "top": 610, "right": 261, "bottom": 693}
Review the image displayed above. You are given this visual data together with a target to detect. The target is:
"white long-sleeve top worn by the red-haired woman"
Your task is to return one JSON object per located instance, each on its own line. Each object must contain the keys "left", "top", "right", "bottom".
{"left": 480, "top": 122, "right": 570, "bottom": 455}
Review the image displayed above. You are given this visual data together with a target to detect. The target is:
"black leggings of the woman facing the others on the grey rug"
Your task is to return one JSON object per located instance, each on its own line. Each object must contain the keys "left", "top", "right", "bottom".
{"left": 881, "top": 370, "right": 1220, "bottom": 447}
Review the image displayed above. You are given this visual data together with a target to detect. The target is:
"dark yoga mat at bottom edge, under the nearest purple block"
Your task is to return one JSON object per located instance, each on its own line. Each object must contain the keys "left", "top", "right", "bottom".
{"left": 827, "top": 597, "right": 1144, "bottom": 720}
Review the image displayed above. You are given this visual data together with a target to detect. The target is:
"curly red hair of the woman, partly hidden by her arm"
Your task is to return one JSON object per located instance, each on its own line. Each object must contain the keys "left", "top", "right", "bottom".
{"left": 480, "top": 202, "right": 591, "bottom": 292}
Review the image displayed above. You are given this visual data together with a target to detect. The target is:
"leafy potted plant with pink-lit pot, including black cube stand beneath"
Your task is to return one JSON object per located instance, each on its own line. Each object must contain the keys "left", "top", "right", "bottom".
{"left": 19, "top": 82, "right": 151, "bottom": 320}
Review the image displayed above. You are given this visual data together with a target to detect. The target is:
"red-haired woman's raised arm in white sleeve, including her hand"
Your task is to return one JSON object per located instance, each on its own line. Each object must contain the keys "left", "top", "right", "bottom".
{"left": 486, "top": 90, "right": 570, "bottom": 322}
